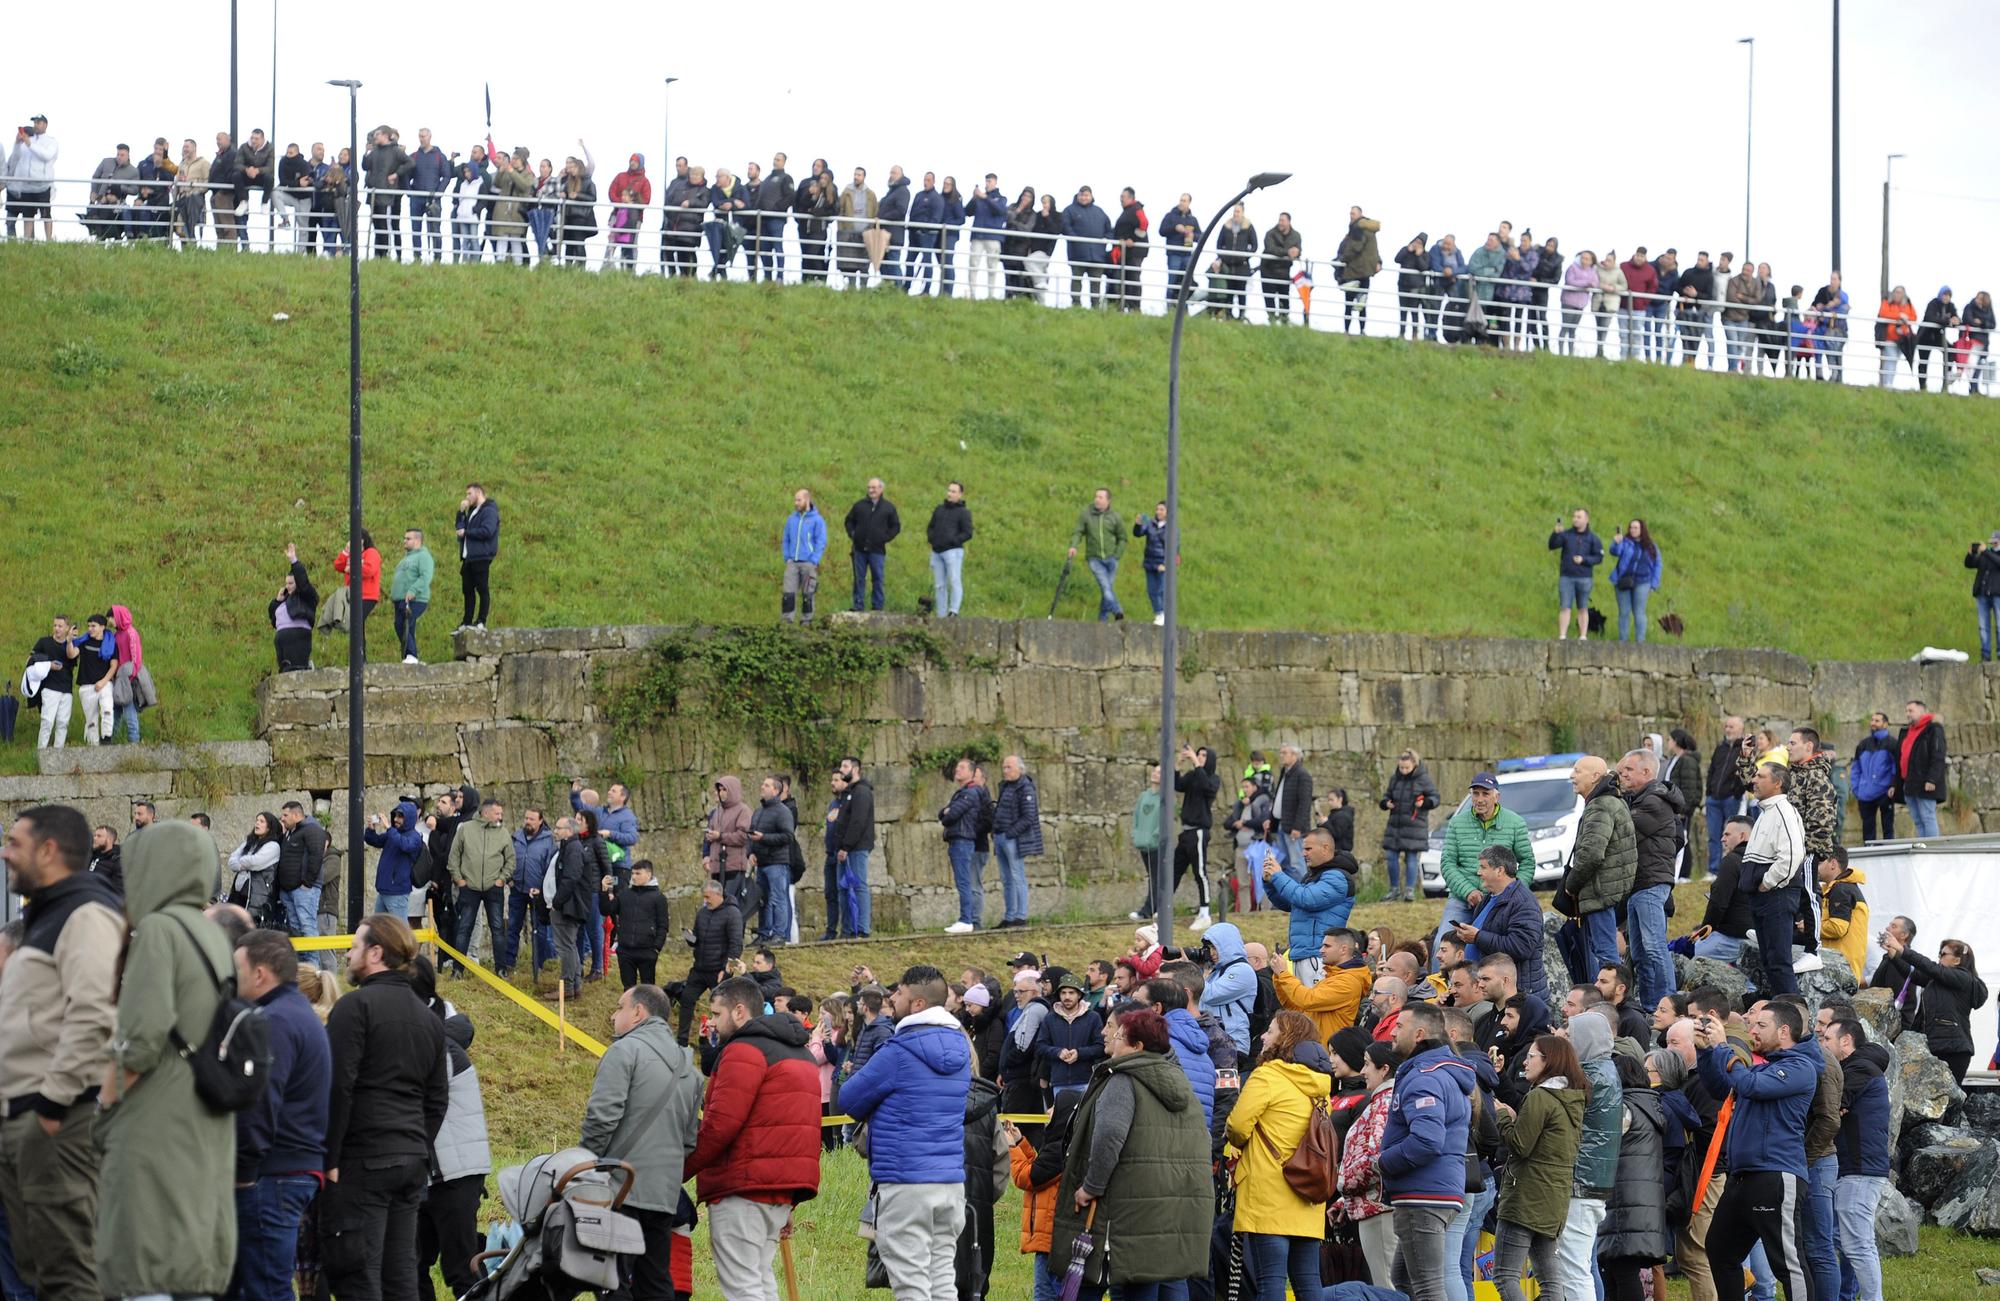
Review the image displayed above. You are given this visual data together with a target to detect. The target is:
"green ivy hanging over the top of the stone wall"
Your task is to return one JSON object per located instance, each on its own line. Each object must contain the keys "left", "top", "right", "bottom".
{"left": 602, "top": 622, "right": 950, "bottom": 777}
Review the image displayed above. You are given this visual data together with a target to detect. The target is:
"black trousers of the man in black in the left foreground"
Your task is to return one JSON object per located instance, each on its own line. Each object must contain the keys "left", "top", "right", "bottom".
{"left": 320, "top": 1153, "right": 430, "bottom": 1301}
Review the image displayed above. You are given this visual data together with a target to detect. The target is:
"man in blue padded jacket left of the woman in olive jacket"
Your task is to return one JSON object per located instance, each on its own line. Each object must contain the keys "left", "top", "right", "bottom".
{"left": 1378, "top": 1003, "right": 1478, "bottom": 1301}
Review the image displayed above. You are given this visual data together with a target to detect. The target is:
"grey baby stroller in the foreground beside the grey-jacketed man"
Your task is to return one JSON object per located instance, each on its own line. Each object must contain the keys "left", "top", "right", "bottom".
{"left": 462, "top": 1147, "right": 646, "bottom": 1301}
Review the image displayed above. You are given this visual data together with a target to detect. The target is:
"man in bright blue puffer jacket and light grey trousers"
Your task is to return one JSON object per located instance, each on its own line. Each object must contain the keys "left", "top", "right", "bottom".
{"left": 840, "top": 967, "right": 972, "bottom": 1301}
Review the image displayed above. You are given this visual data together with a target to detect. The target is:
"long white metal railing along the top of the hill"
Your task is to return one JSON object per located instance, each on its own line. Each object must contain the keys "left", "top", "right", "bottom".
{"left": 6, "top": 168, "right": 1994, "bottom": 394}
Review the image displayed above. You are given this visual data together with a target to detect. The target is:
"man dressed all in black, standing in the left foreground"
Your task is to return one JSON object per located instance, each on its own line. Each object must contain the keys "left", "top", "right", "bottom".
{"left": 320, "top": 913, "right": 450, "bottom": 1301}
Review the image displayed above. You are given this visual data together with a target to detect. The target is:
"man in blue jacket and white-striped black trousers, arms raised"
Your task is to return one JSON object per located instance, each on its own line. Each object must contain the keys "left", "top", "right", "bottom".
{"left": 1694, "top": 1003, "right": 1822, "bottom": 1301}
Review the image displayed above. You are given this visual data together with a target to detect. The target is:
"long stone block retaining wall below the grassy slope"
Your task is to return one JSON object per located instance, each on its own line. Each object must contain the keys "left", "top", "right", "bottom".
{"left": 0, "top": 616, "right": 2000, "bottom": 929}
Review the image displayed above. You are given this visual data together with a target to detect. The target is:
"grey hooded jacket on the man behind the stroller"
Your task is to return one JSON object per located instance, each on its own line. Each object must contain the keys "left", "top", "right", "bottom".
{"left": 582, "top": 1017, "right": 702, "bottom": 1211}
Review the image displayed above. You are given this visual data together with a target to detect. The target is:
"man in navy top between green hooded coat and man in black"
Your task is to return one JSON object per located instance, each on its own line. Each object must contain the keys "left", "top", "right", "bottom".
{"left": 230, "top": 931, "right": 334, "bottom": 1301}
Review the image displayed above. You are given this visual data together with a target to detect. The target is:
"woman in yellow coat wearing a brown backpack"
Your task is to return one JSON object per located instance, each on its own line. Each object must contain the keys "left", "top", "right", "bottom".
{"left": 1226, "top": 1013, "right": 1334, "bottom": 1301}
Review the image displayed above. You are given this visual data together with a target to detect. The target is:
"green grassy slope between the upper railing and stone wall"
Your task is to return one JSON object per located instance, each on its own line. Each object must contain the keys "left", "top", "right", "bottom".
{"left": 0, "top": 246, "right": 1994, "bottom": 765}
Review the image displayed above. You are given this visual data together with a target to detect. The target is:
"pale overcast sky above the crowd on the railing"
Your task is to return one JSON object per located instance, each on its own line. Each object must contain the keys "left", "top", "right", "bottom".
{"left": 19, "top": 0, "right": 2000, "bottom": 310}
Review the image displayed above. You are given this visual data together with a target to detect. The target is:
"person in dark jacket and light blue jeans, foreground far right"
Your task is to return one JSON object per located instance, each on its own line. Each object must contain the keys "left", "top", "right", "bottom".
{"left": 1820, "top": 1019, "right": 1894, "bottom": 1301}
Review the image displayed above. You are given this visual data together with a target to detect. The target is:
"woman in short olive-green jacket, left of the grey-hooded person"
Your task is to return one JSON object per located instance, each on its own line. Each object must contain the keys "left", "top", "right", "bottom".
{"left": 1494, "top": 1035, "right": 1590, "bottom": 1301}
